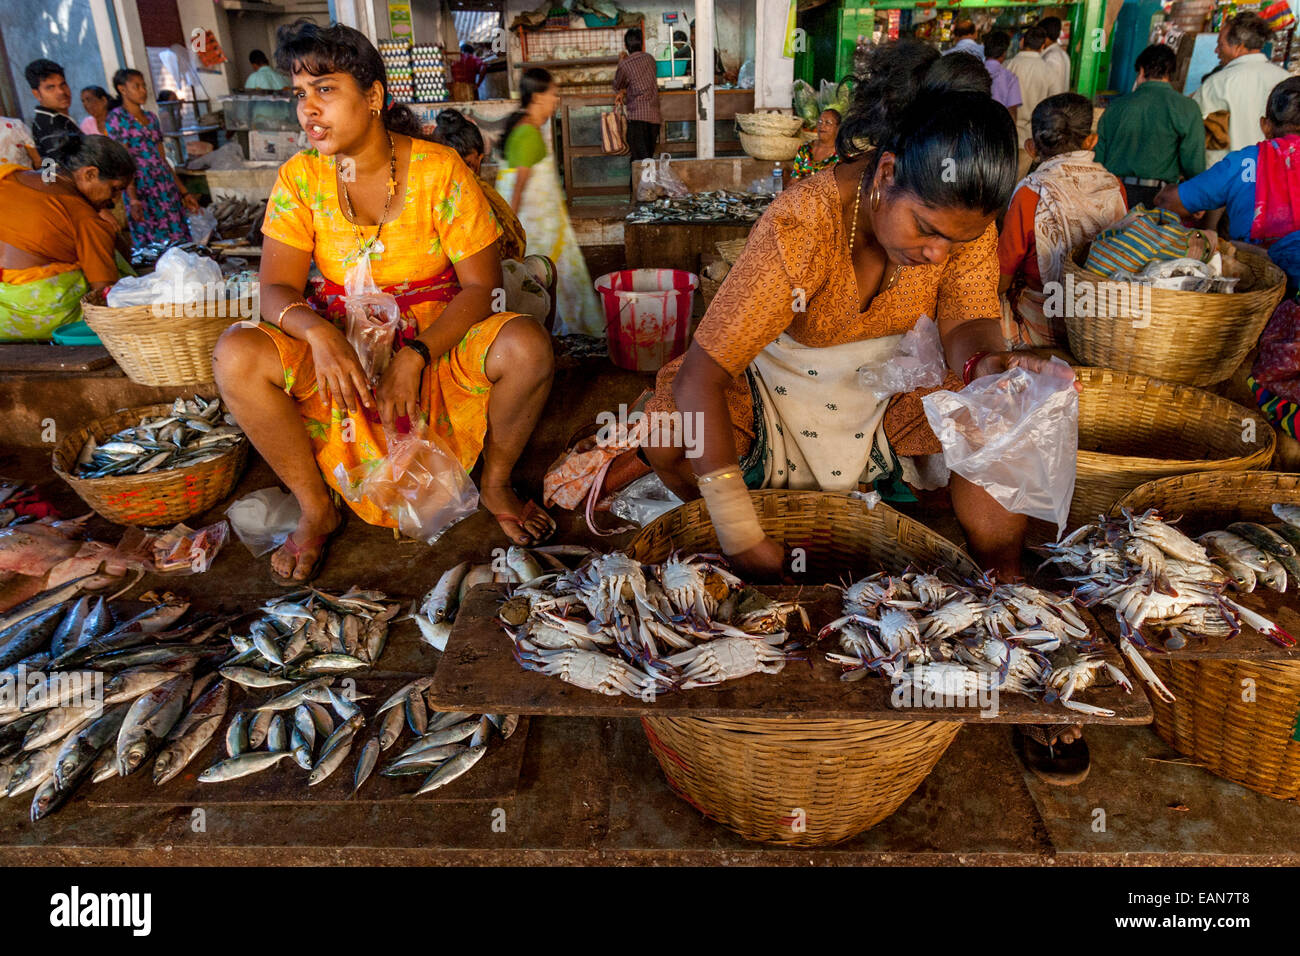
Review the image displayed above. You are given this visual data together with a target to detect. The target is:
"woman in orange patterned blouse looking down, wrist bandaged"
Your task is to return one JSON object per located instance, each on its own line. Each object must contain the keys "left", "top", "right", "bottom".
{"left": 645, "top": 42, "right": 1076, "bottom": 578}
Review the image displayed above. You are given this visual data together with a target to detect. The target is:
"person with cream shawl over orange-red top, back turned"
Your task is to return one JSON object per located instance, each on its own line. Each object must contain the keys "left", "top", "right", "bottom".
{"left": 997, "top": 92, "right": 1127, "bottom": 349}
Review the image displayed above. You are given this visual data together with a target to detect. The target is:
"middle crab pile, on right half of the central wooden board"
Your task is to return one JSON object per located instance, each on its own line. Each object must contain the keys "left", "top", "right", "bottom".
{"left": 819, "top": 571, "right": 1132, "bottom": 717}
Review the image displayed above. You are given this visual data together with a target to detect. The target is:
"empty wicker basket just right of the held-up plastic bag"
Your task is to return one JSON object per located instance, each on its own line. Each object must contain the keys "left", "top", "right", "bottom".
{"left": 1070, "top": 368, "right": 1277, "bottom": 527}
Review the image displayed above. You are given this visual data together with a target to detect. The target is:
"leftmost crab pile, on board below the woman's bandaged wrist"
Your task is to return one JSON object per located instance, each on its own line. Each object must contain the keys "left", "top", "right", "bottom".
{"left": 501, "top": 551, "right": 810, "bottom": 701}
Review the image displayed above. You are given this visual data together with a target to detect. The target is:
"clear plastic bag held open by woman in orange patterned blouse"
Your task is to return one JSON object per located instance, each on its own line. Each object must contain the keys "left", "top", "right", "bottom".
{"left": 920, "top": 358, "right": 1079, "bottom": 535}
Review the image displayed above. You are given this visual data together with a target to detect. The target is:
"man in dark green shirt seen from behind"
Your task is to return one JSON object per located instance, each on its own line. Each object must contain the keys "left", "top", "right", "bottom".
{"left": 1096, "top": 43, "right": 1205, "bottom": 208}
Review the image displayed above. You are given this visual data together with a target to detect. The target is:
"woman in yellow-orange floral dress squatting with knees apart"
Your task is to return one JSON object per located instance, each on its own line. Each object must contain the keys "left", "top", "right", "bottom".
{"left": 213, "top": 22, "right": 554, "bottom": 583}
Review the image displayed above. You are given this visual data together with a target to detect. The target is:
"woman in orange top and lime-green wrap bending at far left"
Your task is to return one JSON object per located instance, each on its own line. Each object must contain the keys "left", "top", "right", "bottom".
{"left": 0, "top": 134, "right": 135, "bottom": 339}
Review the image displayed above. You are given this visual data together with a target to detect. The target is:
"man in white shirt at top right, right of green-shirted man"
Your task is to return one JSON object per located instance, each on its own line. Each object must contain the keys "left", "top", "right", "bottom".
{"left": 1192, "top": 13, "right": 1288, "bottom": 168}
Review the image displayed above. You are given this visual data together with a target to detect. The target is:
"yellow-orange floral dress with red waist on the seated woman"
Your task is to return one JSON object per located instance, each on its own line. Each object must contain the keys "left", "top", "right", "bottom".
{"left": 259, "top": 140, "right": 516, "bottom": 527}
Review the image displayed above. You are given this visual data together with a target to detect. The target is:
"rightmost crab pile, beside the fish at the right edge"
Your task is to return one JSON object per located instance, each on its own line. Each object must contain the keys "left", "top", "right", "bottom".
{"left": 1043, "top": 510, "right": 1295, "bottom": 701}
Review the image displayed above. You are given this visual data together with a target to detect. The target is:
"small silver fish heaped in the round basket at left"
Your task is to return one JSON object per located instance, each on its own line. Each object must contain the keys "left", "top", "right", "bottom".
{"left": 74, "top": 395, "right": 244, "bottom": 479}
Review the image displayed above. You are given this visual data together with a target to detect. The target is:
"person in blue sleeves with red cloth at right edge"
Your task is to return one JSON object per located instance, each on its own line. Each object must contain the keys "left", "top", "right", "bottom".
{"left": 1156, "top": 77, "right": 1300, "bottom": 295}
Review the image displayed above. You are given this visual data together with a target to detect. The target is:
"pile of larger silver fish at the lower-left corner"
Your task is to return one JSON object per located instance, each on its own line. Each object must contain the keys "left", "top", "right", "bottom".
{"left": 0, "top": 580, "right": 229, "bottom": 821}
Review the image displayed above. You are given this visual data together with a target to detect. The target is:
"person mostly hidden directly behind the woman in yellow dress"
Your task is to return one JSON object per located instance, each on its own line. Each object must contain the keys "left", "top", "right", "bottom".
{"left": 433, "top": 109, "right": 555, "bottom": 332}
